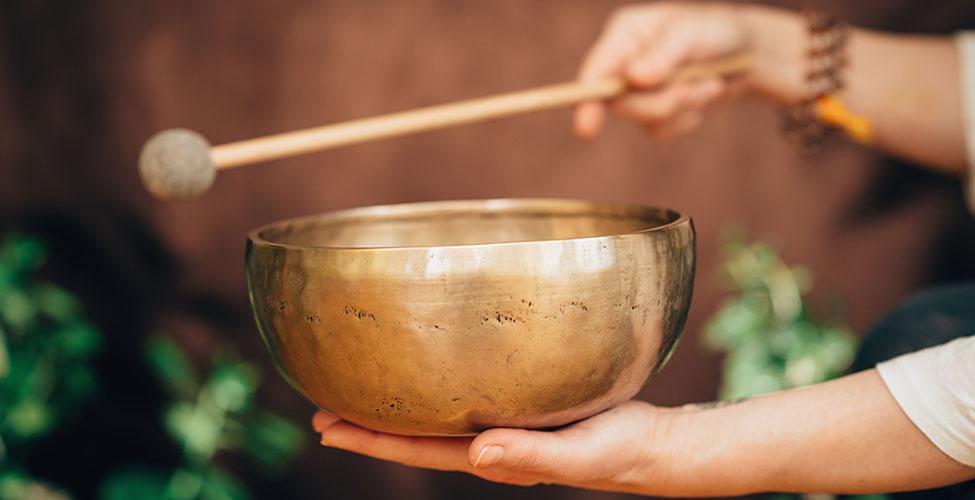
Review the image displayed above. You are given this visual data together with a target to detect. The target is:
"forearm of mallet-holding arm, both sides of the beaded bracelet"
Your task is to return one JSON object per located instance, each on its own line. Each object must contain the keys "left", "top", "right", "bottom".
{"left": 740, "top": 7, "right": 966, "bottom": 174}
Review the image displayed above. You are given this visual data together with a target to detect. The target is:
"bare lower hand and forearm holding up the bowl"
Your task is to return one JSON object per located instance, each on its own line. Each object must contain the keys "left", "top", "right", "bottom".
{"left": 312, "top": 370, "right": 975, "bottom": 497}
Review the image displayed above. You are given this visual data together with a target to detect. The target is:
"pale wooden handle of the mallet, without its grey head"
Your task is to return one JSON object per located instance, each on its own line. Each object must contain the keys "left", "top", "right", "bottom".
{"left": 210, "top": 55, "right": 750, "bottom": 170}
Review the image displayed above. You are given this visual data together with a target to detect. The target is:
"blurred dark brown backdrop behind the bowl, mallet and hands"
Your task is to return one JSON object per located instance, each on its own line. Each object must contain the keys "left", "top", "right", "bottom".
{"left": 0, "top": 0, "right": 975, "bottom": 498}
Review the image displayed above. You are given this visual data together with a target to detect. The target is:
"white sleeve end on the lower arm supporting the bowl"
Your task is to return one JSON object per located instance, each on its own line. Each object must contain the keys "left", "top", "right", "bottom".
{"left": 877, "top": 336, "right": 975, "bottom": 467}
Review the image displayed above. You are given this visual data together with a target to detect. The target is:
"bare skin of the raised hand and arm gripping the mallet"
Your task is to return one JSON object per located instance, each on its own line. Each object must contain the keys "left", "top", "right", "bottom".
{"left": 575, "top": 3, "right": 966, "bottom": 174}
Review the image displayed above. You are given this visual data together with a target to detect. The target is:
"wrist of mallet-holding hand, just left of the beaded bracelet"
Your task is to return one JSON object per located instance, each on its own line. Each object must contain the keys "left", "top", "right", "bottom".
{"left": 737, "top": 5, "right": 807, "bottom": 105}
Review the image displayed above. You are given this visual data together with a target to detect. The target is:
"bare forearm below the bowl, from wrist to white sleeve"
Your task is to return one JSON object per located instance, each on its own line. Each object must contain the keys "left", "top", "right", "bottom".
{"left": 665, "top": 370, "right": 975, "bottom": 496}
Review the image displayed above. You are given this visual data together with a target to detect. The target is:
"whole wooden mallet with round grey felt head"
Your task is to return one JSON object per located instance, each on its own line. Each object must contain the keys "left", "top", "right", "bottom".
{"left": 139, "top": 55, "right": 750, "bottom": 199}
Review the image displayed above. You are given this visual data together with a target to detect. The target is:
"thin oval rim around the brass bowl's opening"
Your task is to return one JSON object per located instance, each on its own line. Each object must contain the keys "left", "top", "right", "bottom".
{"left": 247, "top": 198, "right": 692, "bottom": 253}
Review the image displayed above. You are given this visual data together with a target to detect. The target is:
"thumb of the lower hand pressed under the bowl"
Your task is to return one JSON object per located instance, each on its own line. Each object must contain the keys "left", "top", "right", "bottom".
{"left": 467, "top": 429, "right": 572, "bottom": 476}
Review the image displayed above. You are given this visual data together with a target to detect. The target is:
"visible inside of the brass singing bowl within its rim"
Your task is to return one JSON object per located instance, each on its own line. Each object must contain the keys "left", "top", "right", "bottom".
{"left": 260, "top": 200, "right": 680, "bottom": 248}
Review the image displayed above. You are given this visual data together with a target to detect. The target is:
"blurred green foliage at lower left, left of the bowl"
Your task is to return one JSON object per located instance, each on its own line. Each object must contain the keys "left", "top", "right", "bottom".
{"left": 0, "top": 235, "right": 302, "bottom": 500}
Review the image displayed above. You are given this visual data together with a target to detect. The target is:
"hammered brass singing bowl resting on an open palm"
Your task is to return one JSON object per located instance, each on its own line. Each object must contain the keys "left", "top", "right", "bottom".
{"left": 247, "top": 199, "right": 694, "bottom": 435}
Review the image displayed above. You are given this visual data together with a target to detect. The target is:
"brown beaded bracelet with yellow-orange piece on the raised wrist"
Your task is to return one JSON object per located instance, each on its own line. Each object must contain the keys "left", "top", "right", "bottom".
{"left": 782, "top": 10, "right": 873, "bottom": 152}
